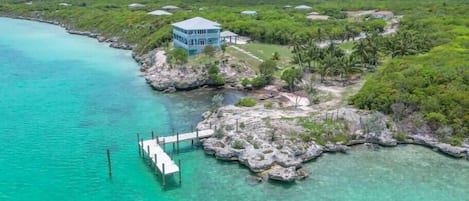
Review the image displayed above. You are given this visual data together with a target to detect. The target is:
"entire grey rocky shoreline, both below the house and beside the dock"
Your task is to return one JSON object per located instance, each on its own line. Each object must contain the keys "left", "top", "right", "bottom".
{"left": 4, "top": 15, "right": 469, "bottom": 182}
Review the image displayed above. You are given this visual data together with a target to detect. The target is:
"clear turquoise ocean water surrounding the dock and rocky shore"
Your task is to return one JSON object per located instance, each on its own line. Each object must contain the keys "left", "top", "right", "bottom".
{"left": 0, "top": 18, "right": 469, "bottom": 201}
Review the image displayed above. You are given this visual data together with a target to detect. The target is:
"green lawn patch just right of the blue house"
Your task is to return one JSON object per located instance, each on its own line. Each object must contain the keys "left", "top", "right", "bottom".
{"left": 237, "top": 43, "right": 292, "bottom": 65}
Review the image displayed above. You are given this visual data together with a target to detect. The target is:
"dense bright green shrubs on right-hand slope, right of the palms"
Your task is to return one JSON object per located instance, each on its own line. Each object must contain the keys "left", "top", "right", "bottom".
{"left": 351, "top": 6, "right": 469, "bottom": 141}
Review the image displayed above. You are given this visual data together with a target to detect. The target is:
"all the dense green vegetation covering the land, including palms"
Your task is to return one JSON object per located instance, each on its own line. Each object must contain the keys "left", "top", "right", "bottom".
{"left": 0, "top": 0, "right": 469, "bottom": 144}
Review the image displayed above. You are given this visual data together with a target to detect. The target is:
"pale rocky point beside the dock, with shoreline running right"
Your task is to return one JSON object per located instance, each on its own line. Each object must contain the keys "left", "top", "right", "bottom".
{"left": 198, "top": 102, "right": 469, "bottom": 182}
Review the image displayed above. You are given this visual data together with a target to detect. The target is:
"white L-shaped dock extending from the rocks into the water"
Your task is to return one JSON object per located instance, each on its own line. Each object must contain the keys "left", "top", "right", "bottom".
{"left": 137, "top": 129, "right": 214, "bottom": 186}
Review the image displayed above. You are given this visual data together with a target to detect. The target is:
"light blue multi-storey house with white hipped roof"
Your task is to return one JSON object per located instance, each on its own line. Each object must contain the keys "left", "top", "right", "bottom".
{"left": 173, "top": 17, "right": 221, "bottom": 55}
